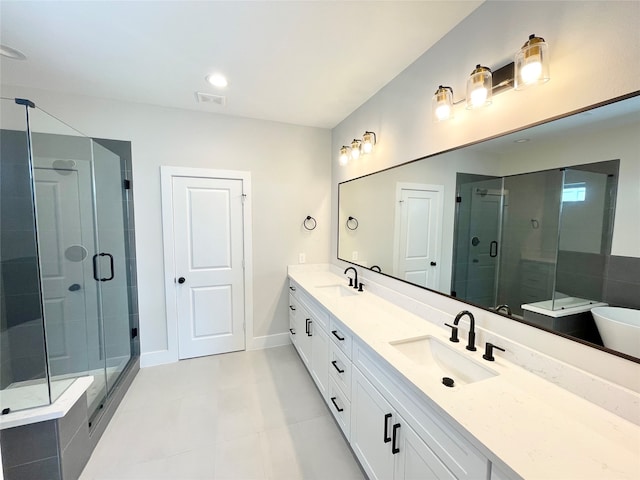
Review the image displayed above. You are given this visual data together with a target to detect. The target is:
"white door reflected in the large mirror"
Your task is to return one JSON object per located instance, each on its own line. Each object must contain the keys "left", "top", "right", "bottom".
{"left": 396, "top": 185, "right": 442, "bottom": 289}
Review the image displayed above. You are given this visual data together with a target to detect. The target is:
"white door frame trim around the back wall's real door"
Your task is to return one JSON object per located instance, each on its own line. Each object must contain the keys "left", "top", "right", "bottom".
{"left": 160, "top": 166, "right": 253, "bottom": 362}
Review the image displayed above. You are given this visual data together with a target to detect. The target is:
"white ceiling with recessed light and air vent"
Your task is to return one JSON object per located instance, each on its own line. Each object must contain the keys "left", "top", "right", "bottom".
{"left": 0, "top": 0, "right": 482, "bottom": 128}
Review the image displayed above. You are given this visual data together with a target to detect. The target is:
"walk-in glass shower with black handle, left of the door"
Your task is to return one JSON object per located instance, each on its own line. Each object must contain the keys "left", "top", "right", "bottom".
{"left": 0, "top": 98, "right": 139, "bottom": 426}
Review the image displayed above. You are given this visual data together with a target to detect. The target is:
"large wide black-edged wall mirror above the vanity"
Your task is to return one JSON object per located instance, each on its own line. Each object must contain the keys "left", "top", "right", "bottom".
{"left": 338, "top": 92, "right": 640, "bottom": 361}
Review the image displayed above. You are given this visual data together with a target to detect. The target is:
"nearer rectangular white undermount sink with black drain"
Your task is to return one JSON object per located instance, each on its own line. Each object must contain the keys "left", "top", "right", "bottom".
{"left": 390, "top": 335, "right": 498, "bottom": 385}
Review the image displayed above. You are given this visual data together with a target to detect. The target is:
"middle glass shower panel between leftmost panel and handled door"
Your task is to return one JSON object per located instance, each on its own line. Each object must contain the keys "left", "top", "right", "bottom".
{"left": 29, "top": 108, "right": 104, "bottom": 401}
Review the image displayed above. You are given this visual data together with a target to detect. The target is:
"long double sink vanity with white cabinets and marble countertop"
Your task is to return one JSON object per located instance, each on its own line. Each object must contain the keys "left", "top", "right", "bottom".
{"left": 289, "top": 265, "right": 640, "bottom": 480}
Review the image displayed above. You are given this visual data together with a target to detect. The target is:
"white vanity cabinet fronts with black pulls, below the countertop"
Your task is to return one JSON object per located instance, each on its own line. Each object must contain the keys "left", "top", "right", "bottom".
{"left": 290, "top": 281, "right": 490, "bottom": 480}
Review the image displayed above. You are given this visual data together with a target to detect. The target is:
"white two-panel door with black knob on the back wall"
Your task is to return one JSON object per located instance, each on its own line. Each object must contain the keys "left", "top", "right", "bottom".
{"left": 172, "top": 176, "right": 245, "bottom": 359}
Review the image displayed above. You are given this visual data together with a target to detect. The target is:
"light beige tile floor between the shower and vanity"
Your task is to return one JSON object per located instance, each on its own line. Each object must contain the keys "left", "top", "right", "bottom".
{"left": 80, "top": 346, "right": 363, "bottom": 480}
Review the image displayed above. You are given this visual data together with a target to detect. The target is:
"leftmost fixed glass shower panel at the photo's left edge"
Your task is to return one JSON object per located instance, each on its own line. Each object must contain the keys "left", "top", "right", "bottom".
{"left": 0, "top": 98, "right": 51, "bottom": 412}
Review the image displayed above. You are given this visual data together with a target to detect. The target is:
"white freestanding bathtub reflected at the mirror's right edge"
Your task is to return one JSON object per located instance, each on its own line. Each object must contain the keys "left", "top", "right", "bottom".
{"left": 591, "top": 307, "right": 640, "bottom": 358}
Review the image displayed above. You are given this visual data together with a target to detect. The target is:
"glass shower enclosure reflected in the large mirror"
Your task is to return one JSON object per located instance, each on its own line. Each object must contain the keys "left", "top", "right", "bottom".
{"left": 452, "top": 160, "right": 620, "bottom": 328}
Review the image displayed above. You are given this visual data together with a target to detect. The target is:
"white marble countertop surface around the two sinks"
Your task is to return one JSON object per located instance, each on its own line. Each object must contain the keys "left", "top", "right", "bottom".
{"left": 289, "top": 268, "right": 640, "bottom": 480}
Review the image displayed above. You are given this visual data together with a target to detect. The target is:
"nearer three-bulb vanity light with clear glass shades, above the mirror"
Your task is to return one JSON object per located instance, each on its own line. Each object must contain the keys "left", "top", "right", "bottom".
{"left": 431, "top": 34, "right": 551, "bottom": 122}
